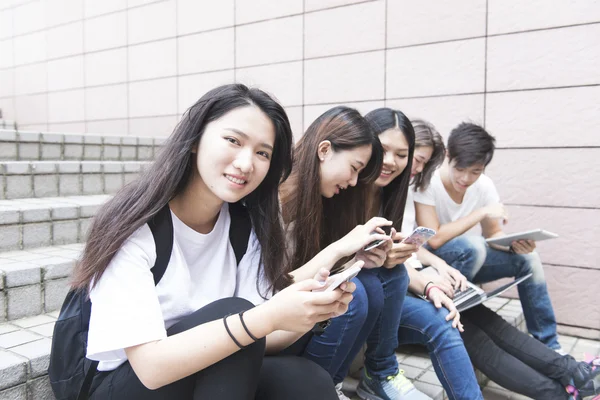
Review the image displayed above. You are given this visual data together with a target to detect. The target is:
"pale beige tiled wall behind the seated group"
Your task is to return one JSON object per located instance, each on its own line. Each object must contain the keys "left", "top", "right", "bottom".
{"left": 0, "top": 0, "right": 600, "bottom": 329}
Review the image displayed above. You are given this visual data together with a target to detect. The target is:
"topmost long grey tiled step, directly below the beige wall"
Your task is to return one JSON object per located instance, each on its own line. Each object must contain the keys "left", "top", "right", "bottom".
{"left": 0, "top": 129, "right": 165, "bottom": 161}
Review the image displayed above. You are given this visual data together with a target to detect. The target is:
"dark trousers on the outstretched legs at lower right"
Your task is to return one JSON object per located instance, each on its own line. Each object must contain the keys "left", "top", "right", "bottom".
{"left": 461, "top": 306, "right": 578, "bottom": 400}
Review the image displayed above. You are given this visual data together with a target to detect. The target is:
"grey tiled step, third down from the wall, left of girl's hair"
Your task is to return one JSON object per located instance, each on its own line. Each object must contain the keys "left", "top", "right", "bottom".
{"left": 0, "top": 195, "right": 111, "bottom": 252}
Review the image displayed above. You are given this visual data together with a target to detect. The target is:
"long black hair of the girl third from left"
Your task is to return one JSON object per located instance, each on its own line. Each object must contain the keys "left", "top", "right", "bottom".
{"left": 365, "top": 108, "right": 415, "bottom": 231}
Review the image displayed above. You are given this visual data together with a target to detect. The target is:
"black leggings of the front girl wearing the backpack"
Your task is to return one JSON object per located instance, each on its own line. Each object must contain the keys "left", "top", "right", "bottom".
{"left": 91, "top": 298, "right": 338, "bottom": 400}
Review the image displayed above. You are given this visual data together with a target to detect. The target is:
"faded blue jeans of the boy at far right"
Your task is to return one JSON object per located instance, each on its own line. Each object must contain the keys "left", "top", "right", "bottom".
{"left": 433, "top": 235, "right": 560, "bottom": 349}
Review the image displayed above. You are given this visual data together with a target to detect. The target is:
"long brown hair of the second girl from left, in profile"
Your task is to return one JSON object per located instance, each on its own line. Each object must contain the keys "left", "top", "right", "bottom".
{"left": 282, "top": 106, "right": 383, "bottom": 271}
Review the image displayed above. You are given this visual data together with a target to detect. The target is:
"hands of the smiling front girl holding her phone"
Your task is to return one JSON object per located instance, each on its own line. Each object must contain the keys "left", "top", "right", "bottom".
{"left": 262, "top": 261, "right": 363, "bottom": 333}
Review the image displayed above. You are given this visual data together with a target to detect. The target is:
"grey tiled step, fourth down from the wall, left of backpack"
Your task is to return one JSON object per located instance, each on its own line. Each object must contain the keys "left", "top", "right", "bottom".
{"left": 0, "top": 244, "right": 83, "bottom": 322}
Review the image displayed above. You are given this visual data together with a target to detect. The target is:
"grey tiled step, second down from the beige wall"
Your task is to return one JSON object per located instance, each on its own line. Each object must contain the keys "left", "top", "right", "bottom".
{"left": 0, "top": 161, "right": 150, "bottom": 199}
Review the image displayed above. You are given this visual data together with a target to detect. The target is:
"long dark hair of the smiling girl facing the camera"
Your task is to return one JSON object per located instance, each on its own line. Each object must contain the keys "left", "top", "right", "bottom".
{"left": 73, "top": 84, "right": 293, "bottom": 290}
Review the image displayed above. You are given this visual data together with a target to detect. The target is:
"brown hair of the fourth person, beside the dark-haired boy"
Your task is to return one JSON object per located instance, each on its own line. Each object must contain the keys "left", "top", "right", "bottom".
{"left": 412, "top": 119, "right": 446, "bottom": 192}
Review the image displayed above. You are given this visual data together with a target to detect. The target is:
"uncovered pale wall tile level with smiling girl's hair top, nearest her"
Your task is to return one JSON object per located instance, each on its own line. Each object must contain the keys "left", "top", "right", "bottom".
{"left": 129, "top": 78, "right": 177, "bottom": 117}
